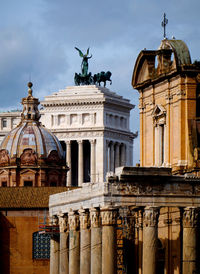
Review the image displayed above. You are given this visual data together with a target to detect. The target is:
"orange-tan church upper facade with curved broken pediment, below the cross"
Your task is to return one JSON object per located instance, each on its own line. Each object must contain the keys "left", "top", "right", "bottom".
{"left": 132, "top": 39, "right": 200, "bottom": 175}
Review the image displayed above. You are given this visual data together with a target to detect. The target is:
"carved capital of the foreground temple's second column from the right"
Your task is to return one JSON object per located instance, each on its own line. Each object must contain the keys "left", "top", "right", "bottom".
{"left": 143, "top": 206, "right": 159, "bottom": 227}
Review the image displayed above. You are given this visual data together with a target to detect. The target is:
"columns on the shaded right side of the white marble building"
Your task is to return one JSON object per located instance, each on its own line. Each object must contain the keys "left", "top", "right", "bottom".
{"left": 106, "top": 140, "right": 126, "bottom": 172}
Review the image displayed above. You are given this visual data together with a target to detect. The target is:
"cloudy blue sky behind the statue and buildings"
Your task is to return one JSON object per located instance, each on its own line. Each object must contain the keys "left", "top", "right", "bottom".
{"left": 0, "top": 0, "right": 200, "bottom": 164}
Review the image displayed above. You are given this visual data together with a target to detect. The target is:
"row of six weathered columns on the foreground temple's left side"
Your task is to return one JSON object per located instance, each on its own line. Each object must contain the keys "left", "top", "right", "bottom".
{"left": 50, "top": 208, "right": 117, "bottom": 274}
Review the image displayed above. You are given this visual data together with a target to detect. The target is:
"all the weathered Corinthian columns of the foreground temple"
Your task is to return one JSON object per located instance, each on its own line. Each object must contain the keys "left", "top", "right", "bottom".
{"left": 50, "top": 206, "right": 199, "bottom": 274}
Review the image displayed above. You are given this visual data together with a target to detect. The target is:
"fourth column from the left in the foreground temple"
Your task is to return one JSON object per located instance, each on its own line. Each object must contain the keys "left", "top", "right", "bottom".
{"left": 79, "top": 209, "right": 91, "bottom": 274}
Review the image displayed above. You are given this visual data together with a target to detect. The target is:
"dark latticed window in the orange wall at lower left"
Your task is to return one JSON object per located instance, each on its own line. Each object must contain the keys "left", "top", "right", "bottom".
{"left": 32, "top": 231, "right": 51, "bottom": 260}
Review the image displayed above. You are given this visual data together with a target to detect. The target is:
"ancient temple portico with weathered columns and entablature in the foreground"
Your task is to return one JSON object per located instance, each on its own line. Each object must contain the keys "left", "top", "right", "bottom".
{"left": 49, "top": 167, "right": 200, "bottom": 274}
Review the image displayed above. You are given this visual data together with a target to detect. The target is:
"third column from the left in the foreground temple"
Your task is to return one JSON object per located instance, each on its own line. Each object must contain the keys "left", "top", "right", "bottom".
{"left": 68, "top": 211, "right": 80, "bottom": 274}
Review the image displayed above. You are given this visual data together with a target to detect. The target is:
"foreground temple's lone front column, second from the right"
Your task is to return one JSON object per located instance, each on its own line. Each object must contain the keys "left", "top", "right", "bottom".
{"left": 143, "top": 206, "right": 159, "bottom": 274}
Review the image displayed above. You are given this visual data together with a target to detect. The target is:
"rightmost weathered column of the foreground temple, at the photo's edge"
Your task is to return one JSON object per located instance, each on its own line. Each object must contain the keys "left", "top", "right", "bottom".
{"left": 182, "top": 207, "right": 200, "bottom": 274}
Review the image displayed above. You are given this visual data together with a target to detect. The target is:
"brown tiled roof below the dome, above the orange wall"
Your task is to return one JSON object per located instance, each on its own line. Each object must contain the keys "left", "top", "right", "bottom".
{"left": 0, "top": 187, "right": 70, "bottom": 209}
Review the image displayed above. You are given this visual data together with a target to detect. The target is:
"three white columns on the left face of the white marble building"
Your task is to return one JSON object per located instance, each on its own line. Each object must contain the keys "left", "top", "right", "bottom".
{"left": 66, "top": 139, "right": 96, "bottom": 186}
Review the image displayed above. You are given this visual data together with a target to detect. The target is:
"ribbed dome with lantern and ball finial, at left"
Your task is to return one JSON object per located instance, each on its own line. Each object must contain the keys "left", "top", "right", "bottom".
{"left": 0, "top": 83, "right": 64, "bottom": 165}
